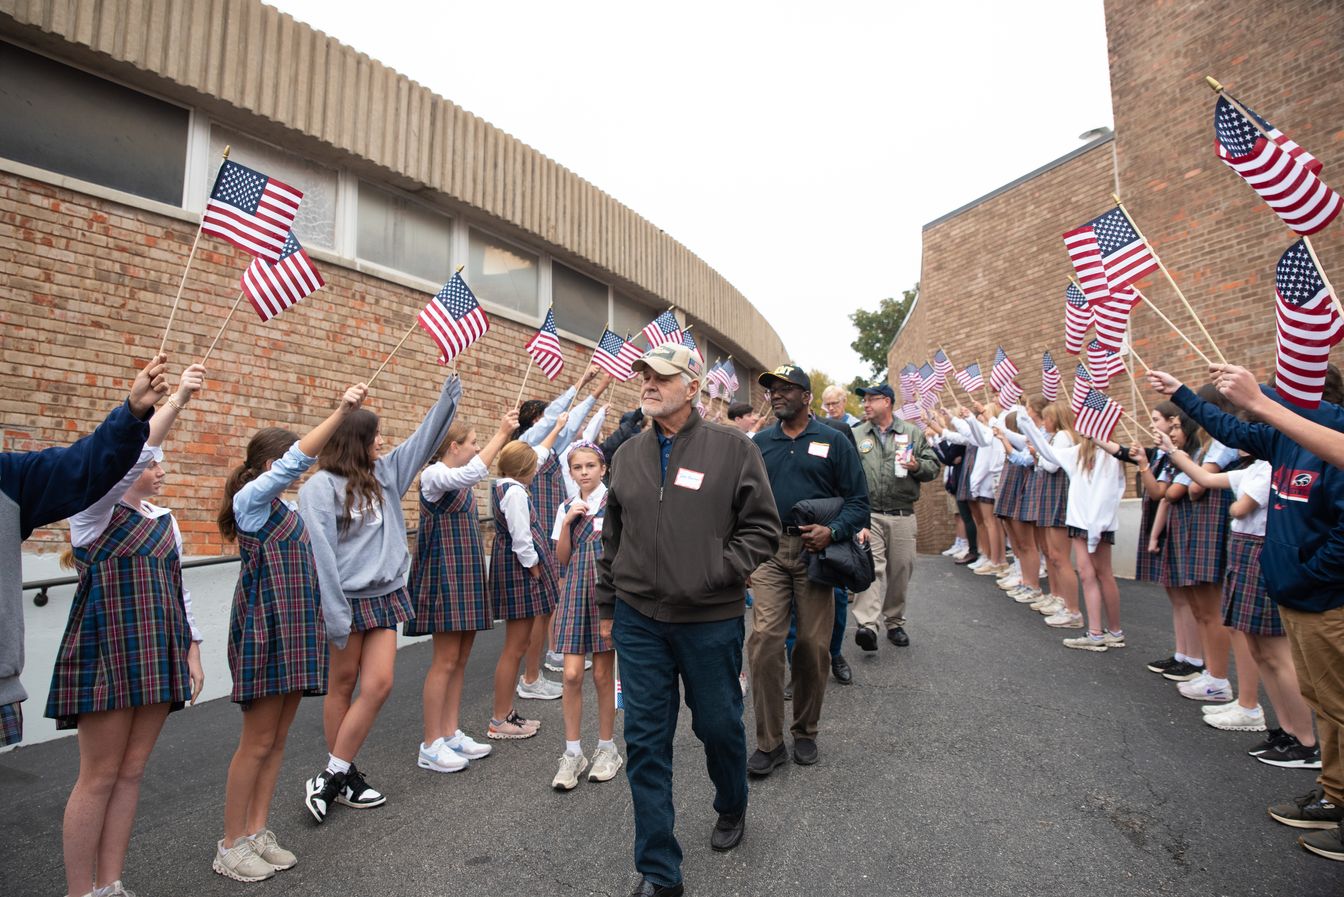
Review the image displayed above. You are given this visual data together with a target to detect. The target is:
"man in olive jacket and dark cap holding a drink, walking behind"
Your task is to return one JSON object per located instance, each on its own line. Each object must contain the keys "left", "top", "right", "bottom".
{"left": 851, "top": 383, "right": 942, "bottom": 651}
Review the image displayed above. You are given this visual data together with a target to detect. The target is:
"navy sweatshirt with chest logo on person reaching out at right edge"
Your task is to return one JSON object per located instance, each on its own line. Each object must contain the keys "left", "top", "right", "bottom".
{"left": 1172, "top": 386, "right": 1344, "bottom": 613}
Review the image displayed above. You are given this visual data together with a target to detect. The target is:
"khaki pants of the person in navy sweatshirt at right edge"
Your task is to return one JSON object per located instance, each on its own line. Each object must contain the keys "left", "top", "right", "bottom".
{"left": 1278, "top": 605, "right": 1344, "bottom": 804}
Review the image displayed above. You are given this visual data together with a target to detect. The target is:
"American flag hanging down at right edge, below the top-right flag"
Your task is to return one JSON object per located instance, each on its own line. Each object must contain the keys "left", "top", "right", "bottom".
{"left": 1274, "top": 239, "right": 1344, "bottom": 407}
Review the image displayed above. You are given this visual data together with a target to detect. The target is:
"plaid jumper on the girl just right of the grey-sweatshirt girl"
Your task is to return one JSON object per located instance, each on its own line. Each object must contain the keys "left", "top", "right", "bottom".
{"left": 402, "top": 490, "right": 495, "bottom": 635}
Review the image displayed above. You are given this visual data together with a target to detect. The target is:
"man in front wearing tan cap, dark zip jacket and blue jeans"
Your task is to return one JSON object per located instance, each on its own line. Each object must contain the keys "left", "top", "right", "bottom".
{"left": 597, "top": 343, "right": 781, "bottom": 897}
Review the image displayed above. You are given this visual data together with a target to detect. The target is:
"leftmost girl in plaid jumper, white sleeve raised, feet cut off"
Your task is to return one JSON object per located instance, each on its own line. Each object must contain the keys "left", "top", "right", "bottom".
{"left": 47, "top": 364, "right": 206, "bottom": 894}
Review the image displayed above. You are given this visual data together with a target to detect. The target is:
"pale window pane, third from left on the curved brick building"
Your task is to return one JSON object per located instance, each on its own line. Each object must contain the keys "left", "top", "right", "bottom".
{"left": 357, "top": 182, "right": 451, "bottom": 281}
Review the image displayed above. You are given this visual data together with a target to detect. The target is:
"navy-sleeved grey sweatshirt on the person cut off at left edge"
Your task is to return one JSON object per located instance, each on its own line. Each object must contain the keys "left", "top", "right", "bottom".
{"left": 0, "top": 402, "right": 149, "bottom": 705}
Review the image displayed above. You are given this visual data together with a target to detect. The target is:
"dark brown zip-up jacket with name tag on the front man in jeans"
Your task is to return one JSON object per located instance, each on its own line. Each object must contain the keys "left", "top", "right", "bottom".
{"left": 597, "top": 410, "right": 781, "bottom": 623}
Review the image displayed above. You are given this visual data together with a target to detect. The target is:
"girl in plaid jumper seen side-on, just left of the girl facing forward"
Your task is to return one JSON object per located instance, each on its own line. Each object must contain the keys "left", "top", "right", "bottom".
{"left": 485, "top": 422, "right": 569, "bottom": 738}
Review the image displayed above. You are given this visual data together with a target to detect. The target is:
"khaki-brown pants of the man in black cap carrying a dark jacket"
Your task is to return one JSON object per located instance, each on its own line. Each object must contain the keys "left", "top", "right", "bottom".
{"left": 747, "top": 535, "right": 836, "bottom": 750}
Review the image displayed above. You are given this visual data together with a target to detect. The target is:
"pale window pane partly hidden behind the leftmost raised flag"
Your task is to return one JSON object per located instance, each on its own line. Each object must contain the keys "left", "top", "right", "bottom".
{"left": 206, "top": 125, "right": 336, "bottom": 249}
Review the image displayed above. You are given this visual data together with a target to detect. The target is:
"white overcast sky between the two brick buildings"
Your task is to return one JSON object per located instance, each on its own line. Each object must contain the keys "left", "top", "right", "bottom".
{"left": 270, "top": 0, "right": 1111, "bottom": 382}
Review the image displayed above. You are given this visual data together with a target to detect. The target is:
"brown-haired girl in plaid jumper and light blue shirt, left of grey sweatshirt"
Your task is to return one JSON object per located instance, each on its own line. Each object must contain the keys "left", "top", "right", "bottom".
{"left": 212, "top": 383, "right": 368, "bottom": 881}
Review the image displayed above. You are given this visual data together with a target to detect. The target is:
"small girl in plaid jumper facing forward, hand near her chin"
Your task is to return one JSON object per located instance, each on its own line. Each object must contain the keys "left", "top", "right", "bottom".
{"left": 551, "top": 442, "right": 622, "bottom": 791}
